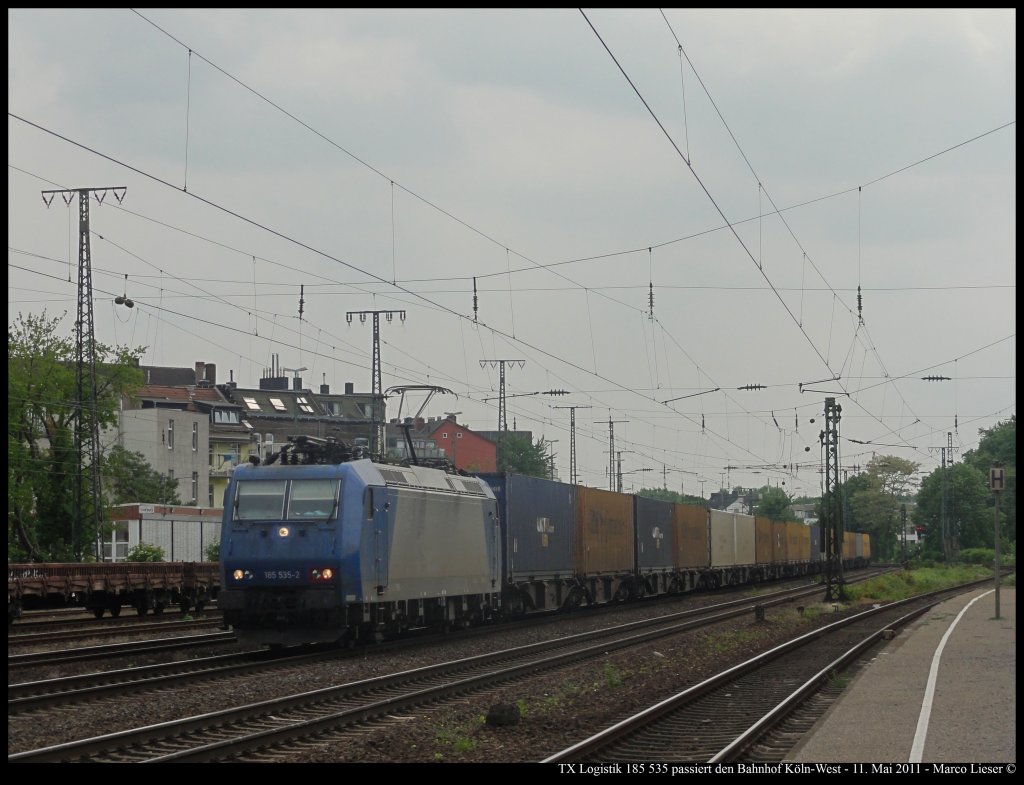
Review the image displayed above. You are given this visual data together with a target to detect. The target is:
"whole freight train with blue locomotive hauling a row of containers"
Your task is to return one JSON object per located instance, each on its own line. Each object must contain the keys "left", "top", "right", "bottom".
{"left": 217, "top": 446, "right": 870, "bottom": 647}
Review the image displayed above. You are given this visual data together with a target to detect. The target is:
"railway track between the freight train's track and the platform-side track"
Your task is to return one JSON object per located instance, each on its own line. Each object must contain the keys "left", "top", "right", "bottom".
{"left": 8, "top": 584, "right": 839, "bottom": 761}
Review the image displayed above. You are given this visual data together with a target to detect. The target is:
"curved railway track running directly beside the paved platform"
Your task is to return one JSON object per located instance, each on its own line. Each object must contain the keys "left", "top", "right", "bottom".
{"left": 542, "top": 581, "right": 988, "bottom": 773}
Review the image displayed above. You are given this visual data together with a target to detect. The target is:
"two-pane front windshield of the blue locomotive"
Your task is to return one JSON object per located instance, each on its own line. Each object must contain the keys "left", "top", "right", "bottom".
{"left": 234, "top": 479, "right": 341, "bottom": 521}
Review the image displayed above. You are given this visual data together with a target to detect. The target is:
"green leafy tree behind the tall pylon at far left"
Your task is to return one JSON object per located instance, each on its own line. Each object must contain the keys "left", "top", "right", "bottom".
{"left": 7, "top": 312, "right": 142, "bottom": 561}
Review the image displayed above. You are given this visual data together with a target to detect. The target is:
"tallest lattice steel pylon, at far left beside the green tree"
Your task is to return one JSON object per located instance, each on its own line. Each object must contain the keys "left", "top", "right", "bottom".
{"left": 42, "top": 185, "right": 126, "bottom": 561}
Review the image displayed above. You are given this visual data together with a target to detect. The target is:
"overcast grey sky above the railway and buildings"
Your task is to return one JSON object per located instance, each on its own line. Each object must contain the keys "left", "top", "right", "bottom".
{"left": 7, "top": 9, "right": 1017, "bottom": 495}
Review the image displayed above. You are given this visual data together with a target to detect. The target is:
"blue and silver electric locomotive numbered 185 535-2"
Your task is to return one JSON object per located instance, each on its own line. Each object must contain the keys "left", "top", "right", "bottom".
{"left": 217, "top": 459, "right": 501, "bottom": 646}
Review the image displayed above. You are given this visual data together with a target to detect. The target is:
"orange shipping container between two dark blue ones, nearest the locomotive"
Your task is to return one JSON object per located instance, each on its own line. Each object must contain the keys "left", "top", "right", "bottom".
{"left": 575, "top": 485, "right": 634, "bottom": 575}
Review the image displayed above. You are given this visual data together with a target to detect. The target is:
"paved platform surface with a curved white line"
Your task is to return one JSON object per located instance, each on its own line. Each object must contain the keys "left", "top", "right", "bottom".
{"left": 786, "top": 586, "right": 1017, "bottom": 775}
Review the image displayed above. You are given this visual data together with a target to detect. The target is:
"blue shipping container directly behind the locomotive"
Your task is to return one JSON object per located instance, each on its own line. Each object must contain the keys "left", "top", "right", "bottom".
{"left": 477, "top": 473, "right": 575, "bottom": 581}
